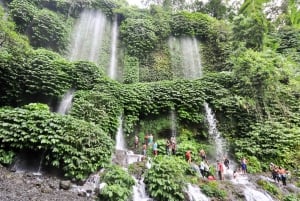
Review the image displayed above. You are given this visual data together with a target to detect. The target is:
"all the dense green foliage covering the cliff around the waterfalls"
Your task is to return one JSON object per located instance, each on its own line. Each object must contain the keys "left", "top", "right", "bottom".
{"left": 0, "top": 0, "right": 300, "bottom": 201}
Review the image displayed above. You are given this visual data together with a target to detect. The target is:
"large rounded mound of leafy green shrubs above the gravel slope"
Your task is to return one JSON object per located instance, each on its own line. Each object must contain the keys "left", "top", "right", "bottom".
{"left": 0, "top": 104, "right": 112, "bottom": 180}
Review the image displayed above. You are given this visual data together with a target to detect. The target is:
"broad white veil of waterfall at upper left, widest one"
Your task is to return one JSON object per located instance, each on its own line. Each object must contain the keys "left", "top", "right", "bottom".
{"left": 68, "top": 10, "right": 107, "bottom": 64}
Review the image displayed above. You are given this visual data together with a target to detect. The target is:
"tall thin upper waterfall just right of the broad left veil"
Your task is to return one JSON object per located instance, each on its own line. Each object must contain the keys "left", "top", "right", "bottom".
{"left": 109, "top": 16, "right": 118, "bottom": 79}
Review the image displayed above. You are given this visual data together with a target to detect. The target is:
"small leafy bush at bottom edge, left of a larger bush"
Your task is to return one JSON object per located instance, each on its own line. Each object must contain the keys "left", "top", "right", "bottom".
{"left": 99, "top": 166, "right": 135, "bottom": 201}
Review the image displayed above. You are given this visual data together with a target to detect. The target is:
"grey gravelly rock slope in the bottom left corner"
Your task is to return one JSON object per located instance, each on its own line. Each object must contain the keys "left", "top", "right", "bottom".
{"left": 0, "top": 167, "right": 95, "bottom": 201}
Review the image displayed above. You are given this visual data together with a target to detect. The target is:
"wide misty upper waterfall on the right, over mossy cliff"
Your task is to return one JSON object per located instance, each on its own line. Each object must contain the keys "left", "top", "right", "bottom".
{"left": 168, "top": 37, "right": 202, "bottom": 79}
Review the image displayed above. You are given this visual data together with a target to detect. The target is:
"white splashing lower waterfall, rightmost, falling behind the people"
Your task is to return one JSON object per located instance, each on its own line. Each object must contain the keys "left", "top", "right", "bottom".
{"left": 204, "top": 103, "right": 226, "bottom": 160}
